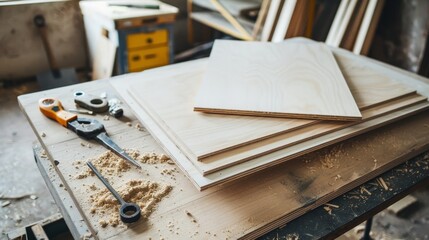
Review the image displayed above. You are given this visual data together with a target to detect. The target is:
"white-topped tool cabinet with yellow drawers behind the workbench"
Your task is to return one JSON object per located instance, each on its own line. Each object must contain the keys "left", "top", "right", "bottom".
{"left": 80, "top": 1, "right": 178, "bottom": 74}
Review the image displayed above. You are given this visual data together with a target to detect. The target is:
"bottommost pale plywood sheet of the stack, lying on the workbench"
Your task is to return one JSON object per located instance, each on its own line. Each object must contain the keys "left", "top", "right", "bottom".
{"left": 115, "top": 40, "right": 429, "bottom": 189}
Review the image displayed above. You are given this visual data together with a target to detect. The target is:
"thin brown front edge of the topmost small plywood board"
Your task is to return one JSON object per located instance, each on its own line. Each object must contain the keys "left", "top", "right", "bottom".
{"left": 194, "top": 107, "right": 362, "bottom": 121}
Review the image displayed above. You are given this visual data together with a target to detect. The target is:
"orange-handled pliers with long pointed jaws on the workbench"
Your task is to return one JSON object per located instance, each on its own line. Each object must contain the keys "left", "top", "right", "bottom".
{"left": 39, "top": 98, "right": 141, "bottom": 168}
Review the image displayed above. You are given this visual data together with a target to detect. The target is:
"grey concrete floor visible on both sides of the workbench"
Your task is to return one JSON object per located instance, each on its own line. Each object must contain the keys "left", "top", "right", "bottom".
{"left": 0, "top": 82, "right": 429, "bottom": 240}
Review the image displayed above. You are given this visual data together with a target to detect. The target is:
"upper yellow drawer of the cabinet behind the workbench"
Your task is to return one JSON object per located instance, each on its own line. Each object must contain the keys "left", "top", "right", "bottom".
{"left": 127, "top": 29, "right": 168, "bottom": 49}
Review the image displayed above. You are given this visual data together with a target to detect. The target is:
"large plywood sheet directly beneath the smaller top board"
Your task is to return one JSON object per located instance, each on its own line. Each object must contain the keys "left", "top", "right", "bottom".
{"left": 126, "top": 40, "right": 413, "bottom": 166}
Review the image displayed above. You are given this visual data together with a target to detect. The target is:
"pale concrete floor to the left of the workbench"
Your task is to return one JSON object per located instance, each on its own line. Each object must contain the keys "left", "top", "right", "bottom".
{"left": 0, "top": 82, "right": 59, "bottom": 239}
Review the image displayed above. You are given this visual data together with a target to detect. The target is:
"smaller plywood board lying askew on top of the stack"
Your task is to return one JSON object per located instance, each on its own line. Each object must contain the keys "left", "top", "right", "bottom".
{"left": 194, "top": 40, "right": 362, "bottom": 121}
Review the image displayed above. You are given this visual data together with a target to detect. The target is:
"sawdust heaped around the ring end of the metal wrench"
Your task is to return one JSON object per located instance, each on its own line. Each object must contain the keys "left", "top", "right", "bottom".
{"left": 90, "top": 180, "right": 172, "bottom": 227}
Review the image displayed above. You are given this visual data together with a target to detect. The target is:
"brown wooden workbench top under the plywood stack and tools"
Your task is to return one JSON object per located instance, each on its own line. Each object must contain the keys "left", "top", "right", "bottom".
{"left": 19, "top": 78, "right": 429, "bottom": 239}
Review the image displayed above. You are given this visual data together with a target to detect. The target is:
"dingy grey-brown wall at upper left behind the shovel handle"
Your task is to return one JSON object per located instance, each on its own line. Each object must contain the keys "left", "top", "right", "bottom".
{"left": 0, "top": 1, "right": 87, "bottom": 80}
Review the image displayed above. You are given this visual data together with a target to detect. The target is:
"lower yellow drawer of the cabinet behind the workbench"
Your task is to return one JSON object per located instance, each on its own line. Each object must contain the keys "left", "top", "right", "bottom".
{"left": 128, "top": 46, "right": 169, "bottom": 72}
